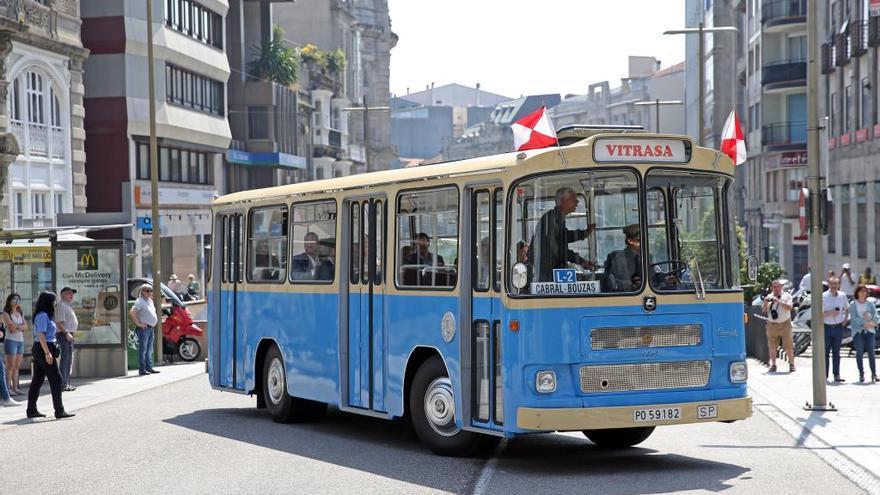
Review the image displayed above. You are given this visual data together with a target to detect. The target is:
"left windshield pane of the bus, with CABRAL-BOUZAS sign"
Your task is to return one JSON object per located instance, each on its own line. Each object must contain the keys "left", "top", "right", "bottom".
{"left": 508, "top": 170, "right": 642, "bottom": 296}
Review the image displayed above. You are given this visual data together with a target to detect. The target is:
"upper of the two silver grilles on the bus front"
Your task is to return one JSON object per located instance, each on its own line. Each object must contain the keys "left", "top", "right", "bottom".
{"left": 590, "top": 324, "right": 703, "bottom": 351}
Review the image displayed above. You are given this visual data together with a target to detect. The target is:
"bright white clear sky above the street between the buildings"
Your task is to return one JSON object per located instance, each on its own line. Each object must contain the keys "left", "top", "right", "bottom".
{"left": 388, "top": 0, "right": 685, "bottom": 98}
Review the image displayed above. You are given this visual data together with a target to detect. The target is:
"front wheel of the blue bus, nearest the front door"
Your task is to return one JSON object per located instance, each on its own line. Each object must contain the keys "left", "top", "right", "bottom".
{"left": 409, "top": 355, "right": 499, "bottom": 457}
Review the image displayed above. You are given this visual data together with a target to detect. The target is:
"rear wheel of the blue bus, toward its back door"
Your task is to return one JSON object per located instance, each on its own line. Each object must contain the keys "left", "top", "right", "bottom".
{"left": 263, "top": 346, "right": 327, "bottom": 423}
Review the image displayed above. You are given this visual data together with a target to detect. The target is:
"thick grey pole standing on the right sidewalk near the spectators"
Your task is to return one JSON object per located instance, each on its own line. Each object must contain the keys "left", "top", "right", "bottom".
{"left": 804, "top": 0, "right": 837, "bottom": 411}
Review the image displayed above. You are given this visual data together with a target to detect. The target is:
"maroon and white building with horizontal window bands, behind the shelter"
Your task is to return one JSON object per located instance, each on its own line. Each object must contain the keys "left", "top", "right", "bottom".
{"left": 82, "top": 0, "right": 231, "bottom": 279}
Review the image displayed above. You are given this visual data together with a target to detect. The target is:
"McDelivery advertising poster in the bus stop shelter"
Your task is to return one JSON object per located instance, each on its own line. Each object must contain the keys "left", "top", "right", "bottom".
{"left": 55, "top": 245, "right": 126, "bottom": 345}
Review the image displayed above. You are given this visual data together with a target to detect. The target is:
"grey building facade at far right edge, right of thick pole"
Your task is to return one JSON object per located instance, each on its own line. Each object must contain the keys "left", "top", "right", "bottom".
{"left": 821, "top": 0, "right": 880, "bottom": 273}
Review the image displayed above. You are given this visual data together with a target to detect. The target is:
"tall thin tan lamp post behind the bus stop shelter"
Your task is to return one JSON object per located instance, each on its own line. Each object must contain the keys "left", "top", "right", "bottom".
{"left": 146, "top": 0, "right": 162, "bottom": 362}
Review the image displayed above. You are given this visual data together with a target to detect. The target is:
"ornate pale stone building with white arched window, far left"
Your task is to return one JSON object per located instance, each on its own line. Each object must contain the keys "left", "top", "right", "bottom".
{"left": 0, "top": 0, "right": 88, "bottom": 229}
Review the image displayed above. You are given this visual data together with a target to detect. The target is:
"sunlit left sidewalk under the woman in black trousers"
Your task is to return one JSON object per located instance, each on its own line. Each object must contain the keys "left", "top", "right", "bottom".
{"left": 0, "top": 361, "right": 208, "bottom": 431}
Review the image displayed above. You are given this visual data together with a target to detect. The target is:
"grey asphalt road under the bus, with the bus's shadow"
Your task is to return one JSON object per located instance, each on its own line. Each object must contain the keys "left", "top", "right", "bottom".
{"left": 0, "top": 375, "right": 862, "bottom": 495}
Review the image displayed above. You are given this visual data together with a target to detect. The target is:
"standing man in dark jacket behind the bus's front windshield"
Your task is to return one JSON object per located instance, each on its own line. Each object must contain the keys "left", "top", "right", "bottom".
{"left": 528, "top": 186, "right": 595, "bottom": 282}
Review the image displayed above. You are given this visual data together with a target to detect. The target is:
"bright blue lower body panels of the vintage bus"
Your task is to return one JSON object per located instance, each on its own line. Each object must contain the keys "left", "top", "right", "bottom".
{"left": 209, "top": 290, "right": 746, "bottom": 433}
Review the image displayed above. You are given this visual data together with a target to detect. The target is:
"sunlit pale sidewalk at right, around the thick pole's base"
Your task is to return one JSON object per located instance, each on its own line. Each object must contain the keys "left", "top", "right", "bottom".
{"left": 749, "top": 348, "right": 880, "bottom": 479}
